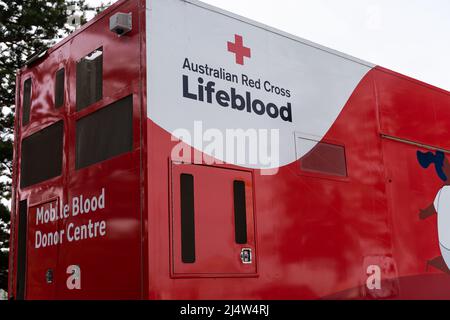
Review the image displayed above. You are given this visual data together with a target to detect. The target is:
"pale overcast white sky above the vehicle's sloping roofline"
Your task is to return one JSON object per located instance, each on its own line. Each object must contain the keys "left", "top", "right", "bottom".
{"left": 88, "top": 0, "right": 450, "bottom": 91}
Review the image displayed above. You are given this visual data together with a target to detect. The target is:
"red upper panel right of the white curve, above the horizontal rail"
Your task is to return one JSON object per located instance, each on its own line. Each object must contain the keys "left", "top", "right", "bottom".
{"left": 374, "top": 68, "right": 450, "bottom": 150}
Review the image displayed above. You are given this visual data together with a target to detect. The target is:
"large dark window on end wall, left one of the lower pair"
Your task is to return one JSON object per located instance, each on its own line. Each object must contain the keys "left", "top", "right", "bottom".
{"left": 20, "top": 121, "right": 64, "bottom": 188}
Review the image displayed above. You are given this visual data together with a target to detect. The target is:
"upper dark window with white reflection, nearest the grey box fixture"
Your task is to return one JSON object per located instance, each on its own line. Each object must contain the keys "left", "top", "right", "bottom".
{"left": 76, "top": 48, "right": 103, "bottom": 111}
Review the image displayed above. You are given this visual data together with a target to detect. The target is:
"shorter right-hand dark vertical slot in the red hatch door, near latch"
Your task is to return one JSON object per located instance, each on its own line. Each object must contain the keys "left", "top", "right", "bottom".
{"left": 233, "top": 180, "right": 247, "bottom": 244}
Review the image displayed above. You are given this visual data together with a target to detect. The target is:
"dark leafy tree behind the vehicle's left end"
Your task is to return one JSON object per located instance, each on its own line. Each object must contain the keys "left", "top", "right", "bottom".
{"left": 0, "top": 0, "right": 112, "bottom": 296}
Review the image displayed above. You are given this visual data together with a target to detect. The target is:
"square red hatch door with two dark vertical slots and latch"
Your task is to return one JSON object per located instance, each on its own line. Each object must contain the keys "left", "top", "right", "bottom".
{"left": 171, "top": 163, "right": 257, "bottom": 277}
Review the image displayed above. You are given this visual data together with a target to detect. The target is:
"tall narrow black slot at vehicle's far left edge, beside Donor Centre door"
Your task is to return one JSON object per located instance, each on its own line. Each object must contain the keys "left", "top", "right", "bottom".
{"left": 16, "top": 200, "right": 28, "bottom": 300}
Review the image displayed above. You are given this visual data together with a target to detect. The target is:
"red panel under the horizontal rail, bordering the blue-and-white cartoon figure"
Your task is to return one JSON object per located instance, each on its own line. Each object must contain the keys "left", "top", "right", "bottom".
{"left": 383, "top": 139, "right": 442, "bottom": 276}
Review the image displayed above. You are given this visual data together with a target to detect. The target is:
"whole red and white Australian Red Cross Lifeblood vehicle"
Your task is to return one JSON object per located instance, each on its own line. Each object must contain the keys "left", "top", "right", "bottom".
{"left": 9, "top": 0, "right": 450, "bottom": 299}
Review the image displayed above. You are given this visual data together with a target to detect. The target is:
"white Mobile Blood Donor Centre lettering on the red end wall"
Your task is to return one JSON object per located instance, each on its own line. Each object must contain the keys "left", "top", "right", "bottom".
{"left": 34, "top": 188, "right": 106, "bottom": 249}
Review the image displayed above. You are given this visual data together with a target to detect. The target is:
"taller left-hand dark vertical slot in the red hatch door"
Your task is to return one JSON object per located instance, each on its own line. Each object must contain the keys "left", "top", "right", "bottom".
{"left": 180, "top": 173, "right": 195, "bottom": 263}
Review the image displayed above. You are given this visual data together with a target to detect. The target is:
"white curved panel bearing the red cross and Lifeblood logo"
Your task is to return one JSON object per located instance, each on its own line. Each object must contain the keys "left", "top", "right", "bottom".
{"left": 146, "top": 0, "right": 373, "bottom": 168}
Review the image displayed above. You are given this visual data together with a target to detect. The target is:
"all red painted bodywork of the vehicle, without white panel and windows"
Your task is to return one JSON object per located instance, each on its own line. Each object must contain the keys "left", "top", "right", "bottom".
{"left": 9, "top": 0, "right": 450, "bottom": 299}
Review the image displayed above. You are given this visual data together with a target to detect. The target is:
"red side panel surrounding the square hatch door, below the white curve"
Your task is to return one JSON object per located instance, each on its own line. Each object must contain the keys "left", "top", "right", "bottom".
{"left": 147, "top": 68, "right": 392, "bottom": 299}
